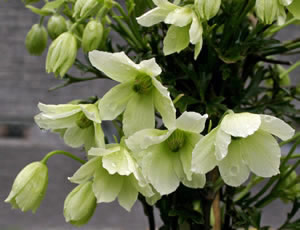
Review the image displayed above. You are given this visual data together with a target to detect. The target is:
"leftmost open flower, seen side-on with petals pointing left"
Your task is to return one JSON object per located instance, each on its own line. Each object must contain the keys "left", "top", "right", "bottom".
{"left": 34, "top": 103, "right": 105, "bottom": 151}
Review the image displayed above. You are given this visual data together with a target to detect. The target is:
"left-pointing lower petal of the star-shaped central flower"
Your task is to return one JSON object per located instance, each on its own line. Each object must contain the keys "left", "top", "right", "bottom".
{"left": 99, "top": 81, "right": 134, "bottom": 120}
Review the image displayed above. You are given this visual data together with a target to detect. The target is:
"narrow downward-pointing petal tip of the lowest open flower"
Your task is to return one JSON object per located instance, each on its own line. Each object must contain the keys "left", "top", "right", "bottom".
{"left": 118, "top": 177, "right": 139, "bottom": 212}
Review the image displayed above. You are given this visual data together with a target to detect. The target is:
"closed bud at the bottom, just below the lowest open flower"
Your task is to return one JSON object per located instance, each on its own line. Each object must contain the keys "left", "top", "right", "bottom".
{"left": 64, "top": 181, "right": 97, "bottom": 226}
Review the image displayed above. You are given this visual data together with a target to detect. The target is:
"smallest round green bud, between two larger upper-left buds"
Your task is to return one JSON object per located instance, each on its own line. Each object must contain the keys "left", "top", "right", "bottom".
{"left": 47, "top": 14, "right": 68, "bottom": 40}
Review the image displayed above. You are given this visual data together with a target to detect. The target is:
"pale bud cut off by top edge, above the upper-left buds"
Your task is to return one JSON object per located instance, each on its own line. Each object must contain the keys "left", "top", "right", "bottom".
{"left": 73, "top": 0, "right": 101, "bottom": 18}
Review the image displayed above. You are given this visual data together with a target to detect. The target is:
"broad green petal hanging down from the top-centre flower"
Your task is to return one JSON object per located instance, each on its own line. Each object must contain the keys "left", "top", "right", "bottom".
{"left": 163, "top": 25, "right": 190, "bottom": 55}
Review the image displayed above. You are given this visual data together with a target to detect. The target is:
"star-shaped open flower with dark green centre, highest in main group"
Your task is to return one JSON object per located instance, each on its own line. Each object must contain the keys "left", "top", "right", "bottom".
{"left": 89, "top": 51, "right": 175, "bottom": 136}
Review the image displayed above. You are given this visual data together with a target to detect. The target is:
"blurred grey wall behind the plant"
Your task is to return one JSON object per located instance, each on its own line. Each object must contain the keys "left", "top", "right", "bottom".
{"left": 0, "top": 0, "right": 300, "bottom": 230}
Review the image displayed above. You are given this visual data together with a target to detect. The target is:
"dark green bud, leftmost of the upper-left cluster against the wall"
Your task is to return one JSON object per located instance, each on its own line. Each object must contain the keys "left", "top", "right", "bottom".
{"left": 25, "top": 24, "right": 48, "bottom": 55}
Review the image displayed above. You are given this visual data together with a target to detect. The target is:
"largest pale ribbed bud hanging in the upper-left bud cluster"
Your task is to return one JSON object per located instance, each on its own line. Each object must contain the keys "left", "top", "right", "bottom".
{"left": 46, "top": 32, "right": 77, "bottom": 77}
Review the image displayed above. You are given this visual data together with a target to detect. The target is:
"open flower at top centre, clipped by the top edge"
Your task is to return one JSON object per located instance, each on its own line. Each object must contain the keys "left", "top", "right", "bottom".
{"left": 137, "top": 0, "right": 203, "bottom": 59}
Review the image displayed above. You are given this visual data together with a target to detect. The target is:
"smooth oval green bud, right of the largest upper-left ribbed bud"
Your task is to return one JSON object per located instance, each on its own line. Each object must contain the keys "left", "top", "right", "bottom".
{"left": 82, "top": 20, "right": 103, "bottom": 53}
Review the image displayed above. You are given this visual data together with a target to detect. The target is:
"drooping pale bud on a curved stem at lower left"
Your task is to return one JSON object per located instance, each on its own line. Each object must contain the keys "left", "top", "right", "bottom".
{"left": 5, "top": 162, "right": 48, "bottom": 213}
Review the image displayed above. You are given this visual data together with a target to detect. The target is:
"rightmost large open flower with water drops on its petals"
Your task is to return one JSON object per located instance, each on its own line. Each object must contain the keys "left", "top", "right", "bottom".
{"left": 192, "top": 112, "right": 294, "bottom": 186}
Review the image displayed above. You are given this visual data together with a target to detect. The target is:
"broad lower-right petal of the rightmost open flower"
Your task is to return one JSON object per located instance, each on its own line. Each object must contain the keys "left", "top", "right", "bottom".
{"left": 239, "top": 131, "right": 280, "bottom": 177}
